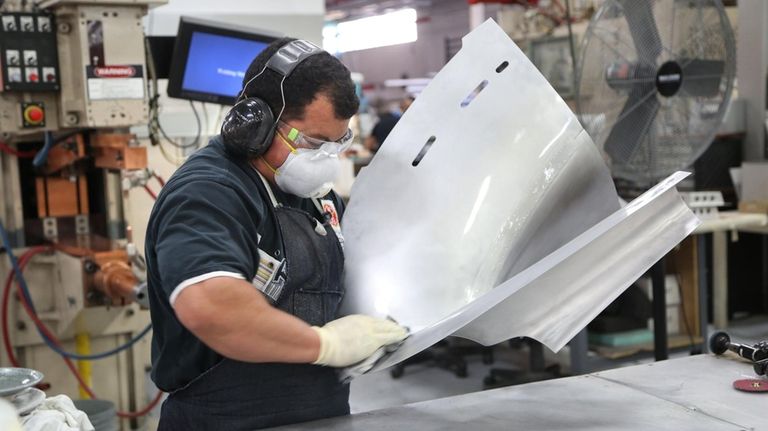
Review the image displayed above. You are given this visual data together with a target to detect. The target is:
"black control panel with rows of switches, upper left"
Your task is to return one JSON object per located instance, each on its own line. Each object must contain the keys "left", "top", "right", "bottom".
{"left": 0, "top": 12, "right": 60, "bottom": 91}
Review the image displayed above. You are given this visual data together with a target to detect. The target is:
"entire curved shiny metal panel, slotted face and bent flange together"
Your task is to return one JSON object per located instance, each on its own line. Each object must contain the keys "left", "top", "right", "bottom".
{"left": 343, "top": 20, "right": 698, "bottom": 377}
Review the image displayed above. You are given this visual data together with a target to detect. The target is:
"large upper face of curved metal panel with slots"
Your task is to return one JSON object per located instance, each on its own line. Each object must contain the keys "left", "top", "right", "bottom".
{"left": 343, "top": 20, "right": 619, "bottom": 335}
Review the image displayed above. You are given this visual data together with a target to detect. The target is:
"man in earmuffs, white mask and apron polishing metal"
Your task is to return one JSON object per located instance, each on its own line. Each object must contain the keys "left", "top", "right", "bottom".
{"left": 146, "top": 39, "right": 407, "bottom": 431}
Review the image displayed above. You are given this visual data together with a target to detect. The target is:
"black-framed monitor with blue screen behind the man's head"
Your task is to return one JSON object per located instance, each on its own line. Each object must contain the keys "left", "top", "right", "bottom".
{"left": 168, "top": 17, "right": 279, "bottom": 105}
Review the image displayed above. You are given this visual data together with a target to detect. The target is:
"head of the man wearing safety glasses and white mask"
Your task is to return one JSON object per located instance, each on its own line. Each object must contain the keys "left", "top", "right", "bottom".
{"left": 225, "top": 38, "right": 359, "bottom": 196}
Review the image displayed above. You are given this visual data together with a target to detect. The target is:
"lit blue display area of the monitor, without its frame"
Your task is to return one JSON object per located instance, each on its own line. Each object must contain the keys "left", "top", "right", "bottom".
{"left": 182, "top": 32, "right": 267, "bottom": 97}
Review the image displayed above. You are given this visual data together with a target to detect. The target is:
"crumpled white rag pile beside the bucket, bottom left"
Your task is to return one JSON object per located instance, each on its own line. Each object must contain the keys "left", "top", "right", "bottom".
{"left": 22, "top": 395, "right": 94, "bottom": 431}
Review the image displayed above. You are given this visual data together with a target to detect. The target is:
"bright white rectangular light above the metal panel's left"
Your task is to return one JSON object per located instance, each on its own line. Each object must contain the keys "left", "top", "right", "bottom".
{"left": 323, "top": 9, "right": 418, "bottom": 53}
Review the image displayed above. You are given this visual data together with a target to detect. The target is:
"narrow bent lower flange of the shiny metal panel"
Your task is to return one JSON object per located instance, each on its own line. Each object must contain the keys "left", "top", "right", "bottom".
{"left": 360, "top": 172, "right": 700, "bottom": 377}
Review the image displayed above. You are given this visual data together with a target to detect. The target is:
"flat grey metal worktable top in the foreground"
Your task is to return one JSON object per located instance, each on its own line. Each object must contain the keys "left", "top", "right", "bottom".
{"left": 268, "top": 355, "right": 768, "bottom": 431}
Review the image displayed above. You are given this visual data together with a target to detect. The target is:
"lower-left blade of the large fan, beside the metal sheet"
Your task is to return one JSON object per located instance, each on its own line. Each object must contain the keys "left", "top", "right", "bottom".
{"left": 603, "top": 84, "right": 659, "bottom": 164}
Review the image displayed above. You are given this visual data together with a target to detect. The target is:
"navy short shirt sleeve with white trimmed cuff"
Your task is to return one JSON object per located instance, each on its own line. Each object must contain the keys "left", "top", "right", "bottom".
{"left": 154, "top": 181, "right": 261, "bottom": 305}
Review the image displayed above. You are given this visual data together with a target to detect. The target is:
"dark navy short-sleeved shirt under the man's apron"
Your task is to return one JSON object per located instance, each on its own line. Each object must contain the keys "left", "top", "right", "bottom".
{"left": 145, "top": 136, "right": 343, "bottom": 391}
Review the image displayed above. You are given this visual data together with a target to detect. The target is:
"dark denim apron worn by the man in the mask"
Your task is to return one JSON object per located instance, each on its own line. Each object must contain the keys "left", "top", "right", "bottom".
{"left": 158, "top": 174, "right": 349, "bottom": 431}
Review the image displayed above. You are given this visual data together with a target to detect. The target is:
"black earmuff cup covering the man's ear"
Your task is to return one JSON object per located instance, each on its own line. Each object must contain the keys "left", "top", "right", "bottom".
{"left": 221, "top": 97, "right": 276, "bottom": 158}
